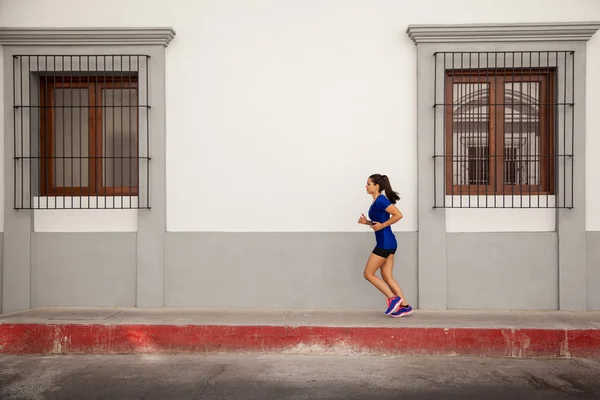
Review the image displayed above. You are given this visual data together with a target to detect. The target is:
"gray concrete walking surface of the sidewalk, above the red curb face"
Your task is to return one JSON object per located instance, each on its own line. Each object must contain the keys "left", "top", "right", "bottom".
{"left": 0, "top": 307, "right": 600, "bottom": 329}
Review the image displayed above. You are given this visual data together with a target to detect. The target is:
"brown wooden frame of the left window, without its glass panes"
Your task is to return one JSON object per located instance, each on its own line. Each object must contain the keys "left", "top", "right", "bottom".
{"left": 40, "top": 76, "right": 139, "bottom": 196}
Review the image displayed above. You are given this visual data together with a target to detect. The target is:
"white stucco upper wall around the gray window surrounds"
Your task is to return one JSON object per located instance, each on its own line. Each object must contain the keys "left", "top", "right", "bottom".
{"left": 0, "top": 0, "right": 600, "bottom": 231}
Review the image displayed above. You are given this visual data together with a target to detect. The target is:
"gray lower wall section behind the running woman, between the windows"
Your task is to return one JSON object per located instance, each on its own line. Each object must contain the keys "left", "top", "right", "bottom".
{"left": 165, "top": 232, "right": 418, "bottom": 309}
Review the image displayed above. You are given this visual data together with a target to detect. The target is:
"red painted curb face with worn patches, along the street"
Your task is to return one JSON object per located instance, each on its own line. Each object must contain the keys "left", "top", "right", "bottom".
{"left": 0, "top": 324, "right": 600, "bottom": 358}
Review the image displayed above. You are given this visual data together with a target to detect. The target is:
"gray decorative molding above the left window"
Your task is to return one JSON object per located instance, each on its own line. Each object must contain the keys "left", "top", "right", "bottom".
{"left": 0, "top": 27, "right": 175, "bottom": 47}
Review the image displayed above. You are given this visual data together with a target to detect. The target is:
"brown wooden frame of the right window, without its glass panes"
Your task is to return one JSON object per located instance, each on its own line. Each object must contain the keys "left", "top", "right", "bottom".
{"left": 444, "top": 68, "right": 556, "bottom": 195}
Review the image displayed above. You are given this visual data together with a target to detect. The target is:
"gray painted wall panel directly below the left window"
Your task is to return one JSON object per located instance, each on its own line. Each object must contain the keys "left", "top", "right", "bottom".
{"left": 31, "top": 232, "right": 136, "bottom": 307}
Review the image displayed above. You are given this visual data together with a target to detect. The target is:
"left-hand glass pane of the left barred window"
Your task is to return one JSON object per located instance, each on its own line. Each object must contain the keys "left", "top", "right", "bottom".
{"left": 53, "top": 88, "right": 89, "bottom": 187}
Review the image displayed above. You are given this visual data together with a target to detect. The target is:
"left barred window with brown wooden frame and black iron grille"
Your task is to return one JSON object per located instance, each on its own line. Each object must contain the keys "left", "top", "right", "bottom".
{"left": 13, "top": 55, "right": 150, "bottom": 209}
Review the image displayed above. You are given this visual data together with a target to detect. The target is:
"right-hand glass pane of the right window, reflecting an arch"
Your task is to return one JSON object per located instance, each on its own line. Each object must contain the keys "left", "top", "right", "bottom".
{"left": 504, "top": 82, "right": 540, "bottom": 185}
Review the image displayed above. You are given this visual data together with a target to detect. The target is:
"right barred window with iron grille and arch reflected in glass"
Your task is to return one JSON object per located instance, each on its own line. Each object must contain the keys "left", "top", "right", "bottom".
{"left": 434, "top": 52, "right": 574, "bottom": 207}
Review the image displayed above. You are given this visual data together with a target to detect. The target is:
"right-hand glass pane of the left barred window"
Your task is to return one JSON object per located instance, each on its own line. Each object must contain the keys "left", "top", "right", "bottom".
{"left": 102, "top": 88, "right": 138, "bottom": 187}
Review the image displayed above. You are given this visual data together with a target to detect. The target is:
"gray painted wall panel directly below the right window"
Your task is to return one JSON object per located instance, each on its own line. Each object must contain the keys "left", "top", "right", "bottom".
{"left": 447, "top": 232, "right": 558, "bottom": 310}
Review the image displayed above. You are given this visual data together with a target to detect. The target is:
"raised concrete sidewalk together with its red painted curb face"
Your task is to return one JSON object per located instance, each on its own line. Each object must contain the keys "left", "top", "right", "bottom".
{"left": 0, "top": 307, "right": 600, "bottom": 357}
